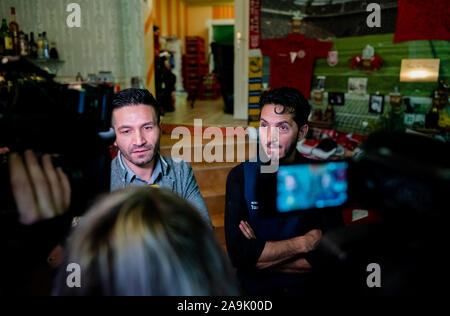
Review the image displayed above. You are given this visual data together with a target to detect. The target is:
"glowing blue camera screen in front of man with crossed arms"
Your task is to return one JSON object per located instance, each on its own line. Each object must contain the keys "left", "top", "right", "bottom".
{"left": 277, "top": 161, "right": 348, "bottom": 212}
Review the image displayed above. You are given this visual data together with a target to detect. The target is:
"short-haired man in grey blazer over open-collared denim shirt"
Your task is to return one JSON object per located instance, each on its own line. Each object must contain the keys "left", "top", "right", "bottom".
{"left": 111, "top": 89, "right": 212, "bottom": 226}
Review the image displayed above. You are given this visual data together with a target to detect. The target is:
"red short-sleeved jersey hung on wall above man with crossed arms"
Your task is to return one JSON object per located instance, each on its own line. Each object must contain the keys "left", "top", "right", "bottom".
{"left": 262, "top": 34, "right": 333, "bottom": 99}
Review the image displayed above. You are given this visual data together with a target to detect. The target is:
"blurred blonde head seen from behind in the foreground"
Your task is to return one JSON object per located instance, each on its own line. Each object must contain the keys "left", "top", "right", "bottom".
{"left": 54, "top": 187, "right": 238, "bottom": 296}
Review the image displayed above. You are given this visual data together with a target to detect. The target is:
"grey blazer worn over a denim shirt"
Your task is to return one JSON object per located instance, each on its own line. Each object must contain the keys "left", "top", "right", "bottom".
{"left": 111, "top": 156, "right": 212, "bottom": 227}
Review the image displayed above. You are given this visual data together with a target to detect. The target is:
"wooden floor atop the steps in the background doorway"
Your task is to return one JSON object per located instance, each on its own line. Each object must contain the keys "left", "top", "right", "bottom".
{"left": 162, "top": 93, "right": 247, "bottom": 127}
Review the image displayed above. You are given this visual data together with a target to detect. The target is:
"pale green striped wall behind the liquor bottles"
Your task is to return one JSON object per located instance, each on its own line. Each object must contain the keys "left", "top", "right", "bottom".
{"left": 0, "top": 0, "right": 145, "bottom": 86}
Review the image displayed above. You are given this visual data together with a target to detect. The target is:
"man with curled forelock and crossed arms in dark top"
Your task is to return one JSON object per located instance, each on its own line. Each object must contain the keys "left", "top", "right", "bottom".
{"left": 225, "top": 88, "right": 330, "bottom": 295}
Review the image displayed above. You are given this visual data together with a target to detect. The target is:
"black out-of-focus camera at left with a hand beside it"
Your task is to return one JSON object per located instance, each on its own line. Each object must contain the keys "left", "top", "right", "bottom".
{"left": 0, "top": 58, "right": 114, "bottom": 215}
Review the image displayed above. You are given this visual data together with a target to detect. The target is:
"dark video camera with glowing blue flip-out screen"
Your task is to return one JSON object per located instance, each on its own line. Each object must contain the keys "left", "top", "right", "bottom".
{"left": 276, "top": 132, "right": 450, "bottom": 218}
